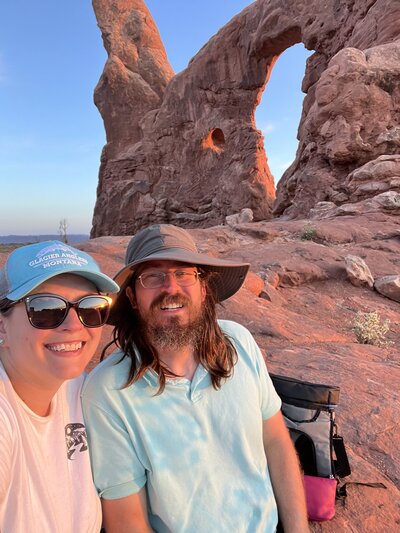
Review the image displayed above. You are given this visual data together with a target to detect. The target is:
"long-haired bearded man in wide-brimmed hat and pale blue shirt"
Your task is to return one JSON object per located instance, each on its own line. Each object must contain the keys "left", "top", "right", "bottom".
{"left": 83, "top": 224, "right": 309, "bottom": 533}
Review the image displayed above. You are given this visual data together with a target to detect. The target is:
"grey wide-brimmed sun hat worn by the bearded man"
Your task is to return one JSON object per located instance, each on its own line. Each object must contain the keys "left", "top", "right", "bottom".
{"left": 114, "top": 224, "right": 250, "bottom": 302}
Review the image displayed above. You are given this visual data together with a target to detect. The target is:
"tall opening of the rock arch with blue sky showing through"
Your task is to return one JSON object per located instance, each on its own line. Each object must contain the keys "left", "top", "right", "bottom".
{"left": 255, "top": 43, "right": 313, "bottom": 184}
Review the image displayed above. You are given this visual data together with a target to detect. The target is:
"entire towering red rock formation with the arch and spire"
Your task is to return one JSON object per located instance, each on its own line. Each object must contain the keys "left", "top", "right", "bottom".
{"left": 92, "top": 0, "right": 400, "bottom": 236}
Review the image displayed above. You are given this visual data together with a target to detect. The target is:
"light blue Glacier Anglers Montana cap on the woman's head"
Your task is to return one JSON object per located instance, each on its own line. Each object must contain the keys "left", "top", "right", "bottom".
{"left": 0, "top": 241, "right": 119, "bottom": 301}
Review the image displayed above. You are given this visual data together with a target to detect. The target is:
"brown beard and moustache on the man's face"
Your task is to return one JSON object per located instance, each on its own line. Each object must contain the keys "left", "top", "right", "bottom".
{"left": 140, "top": 295, "right": 205, "bottom": 352}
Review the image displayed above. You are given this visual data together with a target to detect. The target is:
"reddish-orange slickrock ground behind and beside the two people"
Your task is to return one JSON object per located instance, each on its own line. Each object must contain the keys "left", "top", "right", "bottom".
{"left": 81, "top": 213, "right": 400, "bottom": 533}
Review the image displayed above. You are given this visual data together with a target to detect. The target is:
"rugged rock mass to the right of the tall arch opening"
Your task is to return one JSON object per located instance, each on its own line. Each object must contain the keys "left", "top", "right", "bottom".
{"left": 274, "top": 41, "right": 400, "bottom": 217}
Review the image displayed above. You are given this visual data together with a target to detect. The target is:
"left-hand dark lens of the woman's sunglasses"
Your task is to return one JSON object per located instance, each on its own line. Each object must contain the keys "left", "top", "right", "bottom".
{"left": 27, "top": 296, "right": 67, "bottom": 329}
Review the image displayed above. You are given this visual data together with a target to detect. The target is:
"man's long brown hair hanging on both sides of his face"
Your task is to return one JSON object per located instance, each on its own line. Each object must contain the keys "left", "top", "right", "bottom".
{"left": 101, "top": 272, "right": 237, "bottom": 394}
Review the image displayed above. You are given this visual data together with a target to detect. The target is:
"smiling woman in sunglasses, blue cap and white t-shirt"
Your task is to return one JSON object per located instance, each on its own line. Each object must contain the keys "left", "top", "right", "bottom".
{"left": 0, "top": 241, "right": 118, "bottom": 533}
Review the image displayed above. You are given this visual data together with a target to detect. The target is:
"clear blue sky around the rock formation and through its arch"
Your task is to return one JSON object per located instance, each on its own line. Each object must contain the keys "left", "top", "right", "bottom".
{"left": 0, "top": 0, "right": 309, "bottom": 235}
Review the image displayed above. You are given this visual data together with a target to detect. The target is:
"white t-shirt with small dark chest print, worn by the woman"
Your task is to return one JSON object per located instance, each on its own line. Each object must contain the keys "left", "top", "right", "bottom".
{"left": 0, "top": 362, "right": 101, "bottom": 533}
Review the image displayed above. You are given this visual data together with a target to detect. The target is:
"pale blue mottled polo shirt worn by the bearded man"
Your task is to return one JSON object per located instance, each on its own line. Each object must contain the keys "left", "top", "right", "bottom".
{"left": 83, "top": 321, "right": 281, "bottom": 533}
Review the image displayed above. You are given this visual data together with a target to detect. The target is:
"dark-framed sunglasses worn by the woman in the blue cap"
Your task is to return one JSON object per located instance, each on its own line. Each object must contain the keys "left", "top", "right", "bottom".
{"left": 12, "top": 294, "right": 112, "bottom": 329}
